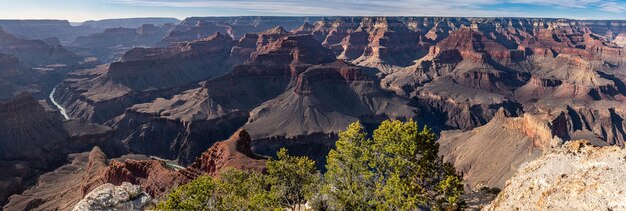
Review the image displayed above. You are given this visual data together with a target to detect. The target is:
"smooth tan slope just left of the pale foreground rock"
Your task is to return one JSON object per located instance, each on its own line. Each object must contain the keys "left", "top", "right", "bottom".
{"left": 439, "top": 110, "right": 569, "bottom": 190}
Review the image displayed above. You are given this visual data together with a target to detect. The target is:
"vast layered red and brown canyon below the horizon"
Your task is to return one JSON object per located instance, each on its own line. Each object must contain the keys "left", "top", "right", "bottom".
{"left": 0, "top": 17, "right": 626, "bottom": 210}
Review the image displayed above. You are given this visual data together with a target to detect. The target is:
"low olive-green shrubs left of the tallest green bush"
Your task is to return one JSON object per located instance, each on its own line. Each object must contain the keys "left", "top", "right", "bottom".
{"left": 157, "top": 149, "right": 321, "bottom": 210}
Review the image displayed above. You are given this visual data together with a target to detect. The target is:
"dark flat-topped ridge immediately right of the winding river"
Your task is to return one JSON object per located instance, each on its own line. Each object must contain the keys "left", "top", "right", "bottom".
{"left": 54, "top": 34, "right": 234, "bottom": 123}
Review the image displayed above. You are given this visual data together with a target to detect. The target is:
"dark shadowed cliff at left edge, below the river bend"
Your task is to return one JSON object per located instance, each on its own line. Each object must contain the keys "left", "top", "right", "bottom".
{"left": 0, "top": 94, "right": 116, "bottom": 204}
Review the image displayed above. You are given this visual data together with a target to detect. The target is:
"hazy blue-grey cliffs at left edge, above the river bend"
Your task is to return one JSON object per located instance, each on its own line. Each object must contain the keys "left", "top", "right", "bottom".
{"left": 0, "top": 28, "right": 96, "bottom": 100}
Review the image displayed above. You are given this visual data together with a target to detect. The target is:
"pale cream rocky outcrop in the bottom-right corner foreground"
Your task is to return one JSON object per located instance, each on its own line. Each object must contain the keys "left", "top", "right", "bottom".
{"left": 485, "top": 141, "right": 626, "bottom": 210}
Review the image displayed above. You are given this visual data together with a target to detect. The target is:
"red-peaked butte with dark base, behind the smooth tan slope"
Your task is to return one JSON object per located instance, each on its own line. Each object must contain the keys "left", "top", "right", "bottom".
{"left": 381, "top": 28, "right": 526, "bottom": 130}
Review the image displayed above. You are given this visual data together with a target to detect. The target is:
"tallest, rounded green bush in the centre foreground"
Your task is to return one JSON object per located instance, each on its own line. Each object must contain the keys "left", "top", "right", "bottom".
{"left": 323, "top": 121, "right": 463, "bottom": 210}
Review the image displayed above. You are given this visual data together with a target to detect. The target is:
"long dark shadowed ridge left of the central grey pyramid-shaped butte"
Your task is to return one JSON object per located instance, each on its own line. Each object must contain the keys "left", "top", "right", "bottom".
{"left": 113, "top": 35, "right": 334, "bottom": 164}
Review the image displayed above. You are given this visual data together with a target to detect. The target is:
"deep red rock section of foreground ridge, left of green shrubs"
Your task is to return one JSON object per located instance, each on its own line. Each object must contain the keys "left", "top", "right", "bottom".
{"left": 102, "top": 130, "right": 265, "bottom": 197}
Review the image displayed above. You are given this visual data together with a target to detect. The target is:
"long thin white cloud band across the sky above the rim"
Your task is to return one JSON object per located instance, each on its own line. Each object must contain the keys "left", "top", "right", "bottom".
{"left": 110, "top": 0, "right": 525, "bottom": 16}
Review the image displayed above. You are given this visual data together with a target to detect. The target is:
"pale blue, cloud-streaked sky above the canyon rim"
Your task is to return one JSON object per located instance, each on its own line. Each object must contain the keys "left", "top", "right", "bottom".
{"left": 0, "top": 0, "right": 626, "bottom": 22}
